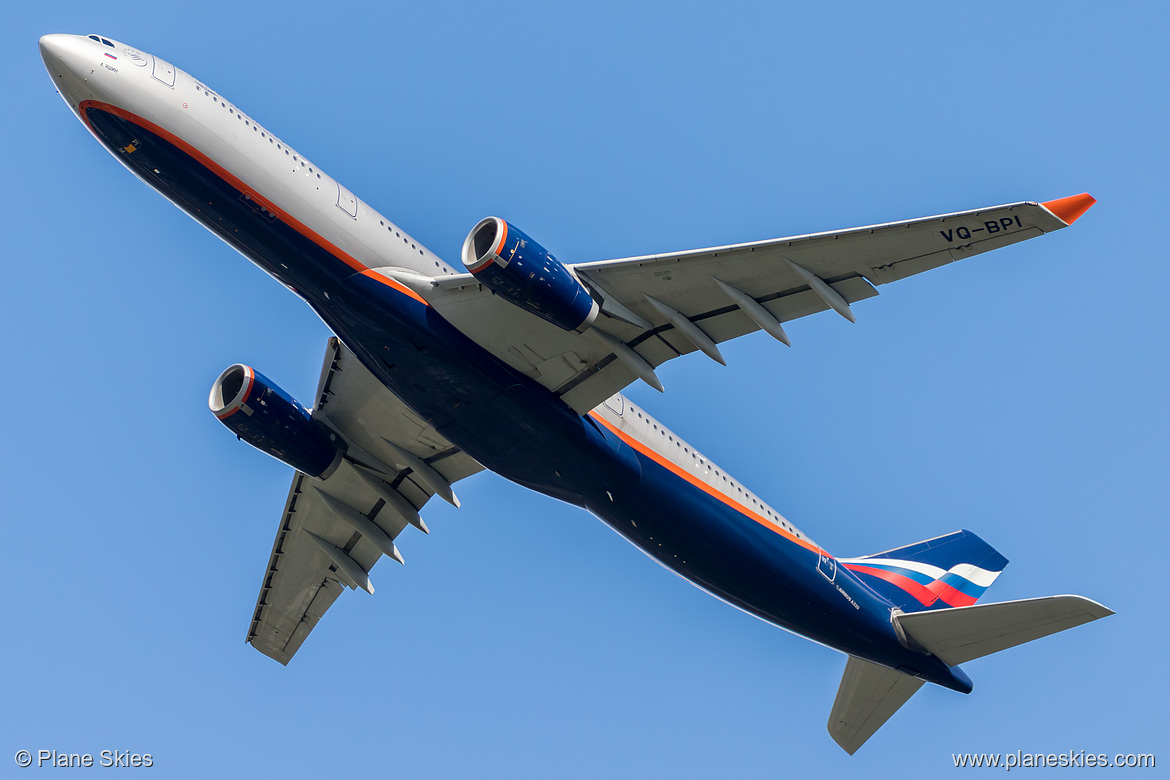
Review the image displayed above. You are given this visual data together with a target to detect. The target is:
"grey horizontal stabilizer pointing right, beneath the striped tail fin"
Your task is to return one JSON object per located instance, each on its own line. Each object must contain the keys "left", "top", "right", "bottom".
{"left": 893, "top": 595, "right": 1113, "bottom": 668}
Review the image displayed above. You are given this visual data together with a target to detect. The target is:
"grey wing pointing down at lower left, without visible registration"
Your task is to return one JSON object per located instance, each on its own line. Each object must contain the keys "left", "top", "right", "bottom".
{"left": 247, "top": 338, "right": 483, "bottom": 664}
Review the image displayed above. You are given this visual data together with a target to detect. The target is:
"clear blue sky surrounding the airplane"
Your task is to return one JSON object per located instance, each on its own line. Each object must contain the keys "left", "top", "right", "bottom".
{"left": 0, "top": 0, "right": 1170, "bottom": 778}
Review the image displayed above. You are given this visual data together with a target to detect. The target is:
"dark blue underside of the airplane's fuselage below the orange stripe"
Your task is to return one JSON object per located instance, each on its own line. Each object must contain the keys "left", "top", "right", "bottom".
{"left": 87, "top": 108, "right": 966, "bottom": 690}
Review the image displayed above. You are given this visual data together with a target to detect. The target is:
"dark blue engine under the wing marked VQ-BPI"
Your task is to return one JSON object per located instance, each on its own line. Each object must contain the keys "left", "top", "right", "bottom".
{"left": 462, "top": 216, "right": 598, "bottom": 333}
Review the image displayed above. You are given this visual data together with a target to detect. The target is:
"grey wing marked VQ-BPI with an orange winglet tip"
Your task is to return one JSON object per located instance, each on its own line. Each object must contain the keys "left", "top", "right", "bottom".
{"left": 414, "top": 194, "right": 1095, "bottom": 413}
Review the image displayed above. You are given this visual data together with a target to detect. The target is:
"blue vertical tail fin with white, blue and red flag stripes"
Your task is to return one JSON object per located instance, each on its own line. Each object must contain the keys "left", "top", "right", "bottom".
{"left": 838, "top": 531, "right": 1007, "bottom": 612}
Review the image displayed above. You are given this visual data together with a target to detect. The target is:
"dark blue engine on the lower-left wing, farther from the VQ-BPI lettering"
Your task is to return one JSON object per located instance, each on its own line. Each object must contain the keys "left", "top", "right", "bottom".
{"left": 207, "top": 363, "right": 343, "bottom": 478}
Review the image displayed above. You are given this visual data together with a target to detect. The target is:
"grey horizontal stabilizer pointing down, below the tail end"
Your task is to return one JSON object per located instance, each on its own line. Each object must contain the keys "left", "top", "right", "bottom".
{"left": 828, "top": 656, "right": 922, "bottom": 755}
